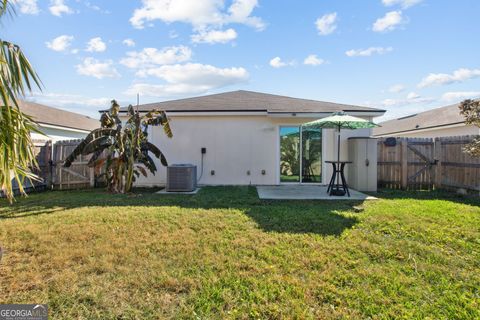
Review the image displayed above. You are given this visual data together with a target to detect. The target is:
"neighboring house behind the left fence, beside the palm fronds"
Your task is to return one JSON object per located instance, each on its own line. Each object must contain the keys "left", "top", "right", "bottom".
{"left": 19, "top": 101, "right": 100, "bottom": 142}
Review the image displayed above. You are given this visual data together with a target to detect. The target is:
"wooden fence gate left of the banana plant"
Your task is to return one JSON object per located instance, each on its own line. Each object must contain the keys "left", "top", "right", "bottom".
{"left": 52, "top": 140, "right": 95, "bottom": 190}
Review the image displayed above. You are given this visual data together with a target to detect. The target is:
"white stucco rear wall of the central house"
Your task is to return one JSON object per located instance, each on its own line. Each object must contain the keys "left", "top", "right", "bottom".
{"left": 132, "top": 115, "right": 371, "bottom": 186}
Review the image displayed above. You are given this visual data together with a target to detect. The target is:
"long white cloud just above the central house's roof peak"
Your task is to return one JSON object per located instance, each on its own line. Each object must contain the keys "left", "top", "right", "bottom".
{"left": 125, "top": 63, "right": 249, "bottom": 97}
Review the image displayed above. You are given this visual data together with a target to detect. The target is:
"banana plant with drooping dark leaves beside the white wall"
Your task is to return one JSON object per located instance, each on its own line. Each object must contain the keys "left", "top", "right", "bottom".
{"left": 64, "top": 100, "right": 173, "bottom": 193}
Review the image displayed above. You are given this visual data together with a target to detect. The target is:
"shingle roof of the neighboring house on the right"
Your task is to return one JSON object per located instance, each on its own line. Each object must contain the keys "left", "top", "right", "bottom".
{"left": 373, "top": 104, "right": 465, "bottom": 136}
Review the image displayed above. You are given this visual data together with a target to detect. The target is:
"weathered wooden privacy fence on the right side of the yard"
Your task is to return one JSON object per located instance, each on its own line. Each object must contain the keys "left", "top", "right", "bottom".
{"left": 378, "top": 136, "right": 480, "bottom": 191}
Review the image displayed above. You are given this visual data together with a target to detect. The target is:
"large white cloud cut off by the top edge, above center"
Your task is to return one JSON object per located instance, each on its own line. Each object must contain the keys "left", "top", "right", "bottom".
{"left": 130, "top": 0, "right": 265, "bottom": 30}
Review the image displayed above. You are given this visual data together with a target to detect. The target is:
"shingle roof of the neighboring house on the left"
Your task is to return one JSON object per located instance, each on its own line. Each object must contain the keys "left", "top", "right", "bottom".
{"left": 19, "top": 101, "right": 99, "bottom": 131}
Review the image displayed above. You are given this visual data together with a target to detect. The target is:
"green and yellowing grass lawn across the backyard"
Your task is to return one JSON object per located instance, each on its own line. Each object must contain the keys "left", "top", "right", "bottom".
{"left": 0, "top": 187, "right": 480, "bottom": 319}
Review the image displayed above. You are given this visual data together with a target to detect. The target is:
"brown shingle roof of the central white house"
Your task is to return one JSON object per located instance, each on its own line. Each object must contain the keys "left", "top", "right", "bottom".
{"left": 117, "top": 90, "right": 385, "bottom": 113}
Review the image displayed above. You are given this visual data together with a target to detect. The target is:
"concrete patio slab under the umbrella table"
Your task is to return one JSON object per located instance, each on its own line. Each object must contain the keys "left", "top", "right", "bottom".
{"left": 257, "top": 185, "right": 377, "bottom": 200}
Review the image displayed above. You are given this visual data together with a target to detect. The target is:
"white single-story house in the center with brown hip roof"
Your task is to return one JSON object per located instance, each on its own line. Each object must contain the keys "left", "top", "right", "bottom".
{"left": 121, "top": 91, "right": 385, "bottom": 186}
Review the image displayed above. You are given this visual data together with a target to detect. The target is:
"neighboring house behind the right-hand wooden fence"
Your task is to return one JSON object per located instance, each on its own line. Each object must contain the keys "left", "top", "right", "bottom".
{"left": 373, "top": 104, "right": 480, "bottom": 138}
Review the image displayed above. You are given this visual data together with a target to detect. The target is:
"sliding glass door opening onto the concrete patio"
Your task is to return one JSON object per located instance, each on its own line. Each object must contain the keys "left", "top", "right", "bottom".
{"left": 280, "top": 126, "right": 322, "bottom": 183}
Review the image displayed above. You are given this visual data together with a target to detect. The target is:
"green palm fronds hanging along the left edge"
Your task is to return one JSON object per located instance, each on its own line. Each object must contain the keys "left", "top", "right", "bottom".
{"left": 0, "top": 25, "right": 42, "bottom": 202}
